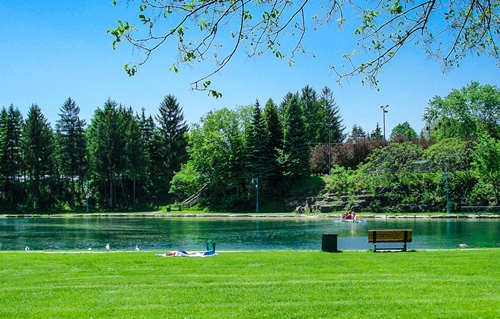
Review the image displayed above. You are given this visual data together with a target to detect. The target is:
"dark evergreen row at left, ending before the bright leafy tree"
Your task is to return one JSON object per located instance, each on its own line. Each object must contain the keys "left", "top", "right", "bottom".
{"left": 0, "top": 95, "right": 188, "bottom": 209}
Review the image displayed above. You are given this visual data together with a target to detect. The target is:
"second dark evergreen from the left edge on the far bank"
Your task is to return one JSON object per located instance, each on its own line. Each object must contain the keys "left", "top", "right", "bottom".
{"left": 23, "top": 105, "right": 54, "bottom": 208}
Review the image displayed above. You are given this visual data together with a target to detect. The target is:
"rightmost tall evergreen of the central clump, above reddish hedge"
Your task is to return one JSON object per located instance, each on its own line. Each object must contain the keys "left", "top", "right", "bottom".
{"left": 320, "top": 86, "right": 345, "bottom": 144}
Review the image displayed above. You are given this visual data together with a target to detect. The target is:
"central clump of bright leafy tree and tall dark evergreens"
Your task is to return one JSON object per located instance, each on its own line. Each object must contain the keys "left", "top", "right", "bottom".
{"left": 171, "top": 86, "right": 344, "bottom": 208}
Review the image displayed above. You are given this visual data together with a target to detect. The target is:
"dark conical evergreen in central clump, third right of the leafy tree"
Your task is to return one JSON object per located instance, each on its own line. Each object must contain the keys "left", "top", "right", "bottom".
{"left": 282, "top": 95, "right": 310, "bottom": 180}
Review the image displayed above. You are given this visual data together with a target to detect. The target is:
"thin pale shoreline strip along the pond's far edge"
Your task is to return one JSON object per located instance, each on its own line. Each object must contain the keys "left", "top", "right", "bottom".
{"left": 0, "top": 211, "right": 500, "bottom": 219}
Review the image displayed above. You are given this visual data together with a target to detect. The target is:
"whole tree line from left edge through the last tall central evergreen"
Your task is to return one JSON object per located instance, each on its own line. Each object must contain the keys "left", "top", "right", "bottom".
{"left": 0, "top": 86, "right": 344, "bottom": 209}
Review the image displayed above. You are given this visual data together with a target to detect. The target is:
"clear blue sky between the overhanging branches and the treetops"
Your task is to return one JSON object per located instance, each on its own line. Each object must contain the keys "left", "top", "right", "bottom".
{"left": 0, "top": 0, "right": 500, "bottom": 134}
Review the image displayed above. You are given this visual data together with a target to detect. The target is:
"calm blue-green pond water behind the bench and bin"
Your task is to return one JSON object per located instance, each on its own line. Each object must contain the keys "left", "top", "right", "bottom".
{"left": 0, "top": 217, "right": 500, "bottom": 250}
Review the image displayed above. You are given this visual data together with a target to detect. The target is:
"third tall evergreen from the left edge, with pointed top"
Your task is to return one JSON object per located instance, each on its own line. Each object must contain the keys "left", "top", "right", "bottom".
{"left": 56, "top": 98, "right": 88, "bottom": 205}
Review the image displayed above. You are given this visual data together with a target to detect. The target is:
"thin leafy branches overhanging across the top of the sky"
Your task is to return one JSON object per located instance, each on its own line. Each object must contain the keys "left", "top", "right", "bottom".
{"left": 108, "top": 0, "right": 500, "bottom": 97}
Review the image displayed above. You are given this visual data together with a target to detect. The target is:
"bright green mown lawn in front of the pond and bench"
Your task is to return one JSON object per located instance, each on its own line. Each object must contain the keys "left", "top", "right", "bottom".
{"left": 0, "top": 249, "right": 500, "bottom": 319}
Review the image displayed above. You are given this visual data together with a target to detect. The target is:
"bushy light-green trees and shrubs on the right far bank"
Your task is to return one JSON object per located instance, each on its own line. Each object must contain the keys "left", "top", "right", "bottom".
{"left": 320, "top": 82, "right": 500, "bottom": 211}
